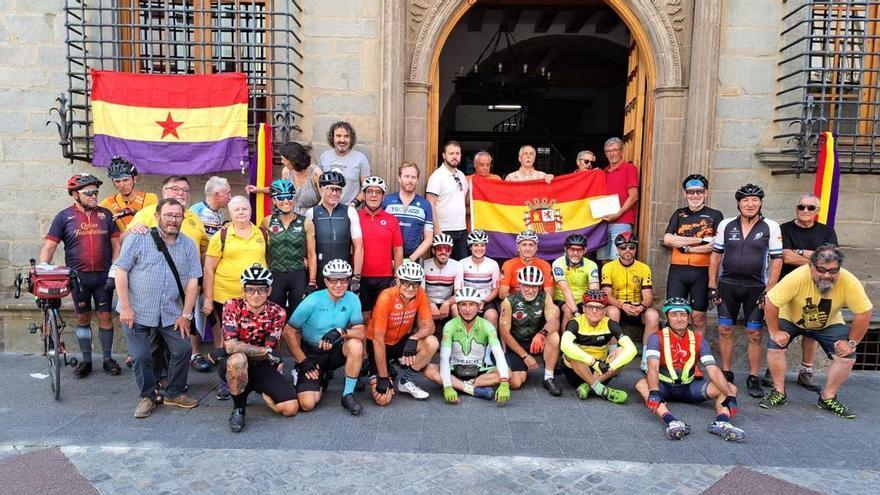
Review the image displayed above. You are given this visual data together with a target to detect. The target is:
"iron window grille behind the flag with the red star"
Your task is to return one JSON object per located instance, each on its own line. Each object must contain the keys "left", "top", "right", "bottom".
{"left": 52, "top": 0, "right": 303, "bottom": 167}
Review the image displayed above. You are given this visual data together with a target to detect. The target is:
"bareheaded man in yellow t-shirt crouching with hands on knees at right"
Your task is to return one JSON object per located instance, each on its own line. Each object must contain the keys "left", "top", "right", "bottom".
{"left": 760, "top": 244, "right": 873, "bottom": 419}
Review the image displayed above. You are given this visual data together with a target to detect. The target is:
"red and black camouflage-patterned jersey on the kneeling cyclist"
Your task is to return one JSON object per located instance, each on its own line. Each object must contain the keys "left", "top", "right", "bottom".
{"left": 223, "top": 298, "right": 287, "bottom": 348}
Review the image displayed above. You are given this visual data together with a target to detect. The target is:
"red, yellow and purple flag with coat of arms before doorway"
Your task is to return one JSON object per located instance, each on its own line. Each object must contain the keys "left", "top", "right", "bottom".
{"left": 471, "top": 170, "right": 607, "bottom": 261}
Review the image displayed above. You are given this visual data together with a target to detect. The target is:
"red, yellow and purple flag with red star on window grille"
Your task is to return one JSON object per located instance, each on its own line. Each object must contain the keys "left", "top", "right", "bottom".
{"left": 92, "top": 70, "right": 248, "bottom": 175}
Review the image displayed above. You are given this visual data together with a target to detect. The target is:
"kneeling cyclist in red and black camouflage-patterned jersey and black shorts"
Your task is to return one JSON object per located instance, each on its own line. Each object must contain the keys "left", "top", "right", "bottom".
{"left": 217, "top": 264, "right": 299, "bottom": 433}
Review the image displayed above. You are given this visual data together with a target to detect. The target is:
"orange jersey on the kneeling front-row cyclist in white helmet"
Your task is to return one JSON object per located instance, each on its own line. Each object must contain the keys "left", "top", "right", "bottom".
{"left": 367, "top": 287, "right": 433, "bottom": 346}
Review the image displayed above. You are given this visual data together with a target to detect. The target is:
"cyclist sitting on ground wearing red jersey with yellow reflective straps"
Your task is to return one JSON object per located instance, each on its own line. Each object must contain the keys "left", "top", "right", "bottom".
{"left": 636, "top": 297, "right": 745, "bottom": 441}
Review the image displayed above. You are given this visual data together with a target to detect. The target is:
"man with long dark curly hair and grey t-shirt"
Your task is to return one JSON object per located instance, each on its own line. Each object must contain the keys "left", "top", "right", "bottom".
{"left": 318, "top": 121, "right": 370, "bottom": 208}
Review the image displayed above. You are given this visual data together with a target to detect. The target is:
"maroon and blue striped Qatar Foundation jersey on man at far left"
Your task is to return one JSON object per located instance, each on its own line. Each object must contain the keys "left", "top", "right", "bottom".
{"left": 46, "top": 205, "right": 119, "bottom": 272}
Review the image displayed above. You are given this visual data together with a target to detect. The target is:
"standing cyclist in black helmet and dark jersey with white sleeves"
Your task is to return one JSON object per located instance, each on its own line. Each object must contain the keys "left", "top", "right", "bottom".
{"left": 709, "top": 184, "right": 782, "bottom": 399}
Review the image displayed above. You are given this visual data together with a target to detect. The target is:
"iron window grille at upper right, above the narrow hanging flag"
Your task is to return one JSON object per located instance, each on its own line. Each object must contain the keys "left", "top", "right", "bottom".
{"left": 774, "top": 0, "right": 880, "bottom": 174}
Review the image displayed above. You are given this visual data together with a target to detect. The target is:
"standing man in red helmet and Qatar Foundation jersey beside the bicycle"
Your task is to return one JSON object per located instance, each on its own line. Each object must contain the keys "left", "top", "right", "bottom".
{"left": 39, "top": 173, "right": 120, "bottom": 378}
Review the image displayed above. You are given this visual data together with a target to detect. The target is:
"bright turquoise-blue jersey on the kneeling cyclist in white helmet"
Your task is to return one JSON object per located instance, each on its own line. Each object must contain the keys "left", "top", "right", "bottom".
{"left": 288, "top": 289, "right": 364, "bottom": 347}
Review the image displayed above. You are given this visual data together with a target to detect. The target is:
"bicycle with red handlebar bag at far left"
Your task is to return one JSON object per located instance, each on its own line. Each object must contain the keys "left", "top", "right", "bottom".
{"left": 14, "top": 259, "right": 79, "bottom": 400}
